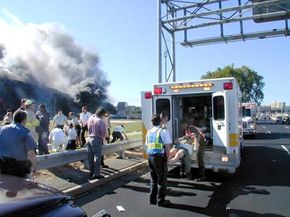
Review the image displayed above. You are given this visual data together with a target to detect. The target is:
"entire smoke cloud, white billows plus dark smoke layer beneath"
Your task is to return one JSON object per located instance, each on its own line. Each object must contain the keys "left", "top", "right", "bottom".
{"left": 0, "top": 15, "right": 114, "bottom": 115}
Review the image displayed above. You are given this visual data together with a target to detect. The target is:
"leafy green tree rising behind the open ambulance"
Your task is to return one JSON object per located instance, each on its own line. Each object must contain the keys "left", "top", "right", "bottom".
{"left": 202, "top": 65, "right": 265, "bottom": 105}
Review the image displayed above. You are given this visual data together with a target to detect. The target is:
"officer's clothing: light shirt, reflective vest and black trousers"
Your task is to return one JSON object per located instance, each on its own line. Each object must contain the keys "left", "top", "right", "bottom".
{"left": 146, "top": 128, "right": 168, "bottom": 205}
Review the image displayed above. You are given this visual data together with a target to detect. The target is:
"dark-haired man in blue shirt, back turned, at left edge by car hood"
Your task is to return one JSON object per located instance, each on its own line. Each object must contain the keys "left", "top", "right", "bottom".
{"left": 0, "top": 110, "right": 37, "bottom": 177}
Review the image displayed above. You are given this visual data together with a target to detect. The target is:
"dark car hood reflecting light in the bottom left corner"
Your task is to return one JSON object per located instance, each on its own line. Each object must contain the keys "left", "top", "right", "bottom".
{"left": 0, "top": 174, "right": 87, "bottom": 217}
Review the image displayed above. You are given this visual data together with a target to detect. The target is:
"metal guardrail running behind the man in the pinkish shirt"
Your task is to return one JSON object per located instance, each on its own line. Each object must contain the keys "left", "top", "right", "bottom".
{"left": 37, "top": 139, "right": 143, "bottom": 169}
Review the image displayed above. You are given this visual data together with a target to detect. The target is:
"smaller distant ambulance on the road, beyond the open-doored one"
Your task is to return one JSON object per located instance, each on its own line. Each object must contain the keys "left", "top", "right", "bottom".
{"left": 242, "top": 103, "right": 257, "bottom": 138}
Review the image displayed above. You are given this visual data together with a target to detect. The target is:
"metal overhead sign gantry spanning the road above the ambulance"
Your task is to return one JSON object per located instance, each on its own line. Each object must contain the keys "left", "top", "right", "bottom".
{"left": 158, "top": 0, "right": 290, "bottom": 83}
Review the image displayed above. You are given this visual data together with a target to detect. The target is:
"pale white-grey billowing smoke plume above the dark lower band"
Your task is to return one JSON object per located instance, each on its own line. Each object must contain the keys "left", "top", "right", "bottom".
{"left": 0, "top": 9, "right": 110, "bottom": 113}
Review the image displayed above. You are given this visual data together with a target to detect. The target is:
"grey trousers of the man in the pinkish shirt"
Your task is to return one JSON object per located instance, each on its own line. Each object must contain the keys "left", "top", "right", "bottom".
{"left": 87, "top": 137, "right": 103, "bottom": 176}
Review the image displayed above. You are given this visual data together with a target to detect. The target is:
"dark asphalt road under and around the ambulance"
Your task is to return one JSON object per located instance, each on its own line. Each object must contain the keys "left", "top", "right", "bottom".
{"left": 77, "top": 122, "right": 290, "bottom": 217}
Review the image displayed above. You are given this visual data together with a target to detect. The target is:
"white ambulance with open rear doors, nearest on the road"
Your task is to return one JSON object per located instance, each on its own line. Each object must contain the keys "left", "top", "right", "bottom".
{"left": 141, "top": 77, "right": 243, "bottom": 174}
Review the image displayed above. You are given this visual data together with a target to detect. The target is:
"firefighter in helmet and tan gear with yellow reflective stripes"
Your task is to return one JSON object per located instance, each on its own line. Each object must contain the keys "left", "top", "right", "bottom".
{"left": 24, "top": 99, "right": 38, "bottom": 141}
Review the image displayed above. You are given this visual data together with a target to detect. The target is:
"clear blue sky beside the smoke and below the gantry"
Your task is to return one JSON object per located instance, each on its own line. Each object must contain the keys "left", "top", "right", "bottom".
{"left": 0, "top": 0, "right": 290, "bottom": 106}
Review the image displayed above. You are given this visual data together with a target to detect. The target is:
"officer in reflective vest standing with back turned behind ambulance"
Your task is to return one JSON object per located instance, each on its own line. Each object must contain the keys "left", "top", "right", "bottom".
{"left": 146, "top": 115, "right": 172, "bottom": 206}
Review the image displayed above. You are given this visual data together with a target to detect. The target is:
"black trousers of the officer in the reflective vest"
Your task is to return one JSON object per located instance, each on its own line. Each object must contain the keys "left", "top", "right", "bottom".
{"left": 148, "top": 155, "right": 168, "bottom": 203}
